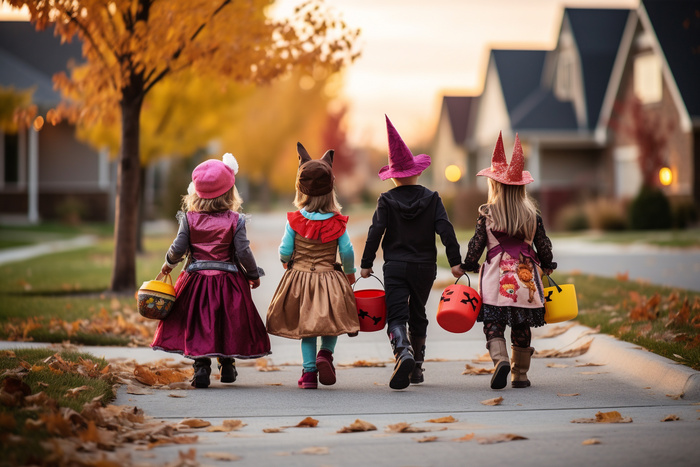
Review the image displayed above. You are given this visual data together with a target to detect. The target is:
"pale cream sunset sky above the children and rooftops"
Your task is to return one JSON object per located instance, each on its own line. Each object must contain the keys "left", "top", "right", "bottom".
{"left": 0, "top": 0, "right": 639, "bottom": 148}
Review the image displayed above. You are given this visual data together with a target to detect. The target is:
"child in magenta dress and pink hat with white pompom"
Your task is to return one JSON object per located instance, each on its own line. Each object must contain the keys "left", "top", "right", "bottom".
{"left": 151, "top": 153, "right": 270, "bottom": 388}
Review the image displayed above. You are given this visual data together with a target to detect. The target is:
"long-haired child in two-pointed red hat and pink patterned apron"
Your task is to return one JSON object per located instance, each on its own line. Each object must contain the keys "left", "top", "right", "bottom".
{"left": 462, "top": 134, "right": 557, "bottom": 389}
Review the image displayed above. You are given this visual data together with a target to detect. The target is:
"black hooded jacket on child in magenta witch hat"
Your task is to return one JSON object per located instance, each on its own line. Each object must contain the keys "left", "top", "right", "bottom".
{"left": 360, "top": 185, "right": 461, "bottom": 269}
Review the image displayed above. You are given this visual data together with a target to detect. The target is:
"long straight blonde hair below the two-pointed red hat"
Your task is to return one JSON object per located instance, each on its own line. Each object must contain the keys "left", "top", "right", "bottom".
{"left": 479, "top": 178, "right": 537, "bottom": 240}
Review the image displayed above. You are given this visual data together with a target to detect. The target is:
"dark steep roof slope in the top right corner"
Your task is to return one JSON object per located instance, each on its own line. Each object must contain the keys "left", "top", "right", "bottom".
{"left": 642, "top": 0, "right": 700, "bottom": 118}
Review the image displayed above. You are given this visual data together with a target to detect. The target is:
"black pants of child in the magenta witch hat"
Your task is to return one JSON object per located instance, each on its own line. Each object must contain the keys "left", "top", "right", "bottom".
{"left": 383, "top": 261, "right": 437, "bottom": 337}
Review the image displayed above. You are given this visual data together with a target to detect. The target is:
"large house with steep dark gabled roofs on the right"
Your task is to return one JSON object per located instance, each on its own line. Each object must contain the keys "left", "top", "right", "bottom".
{"left": 436, "top": 0, "right": 700, "bottom": 227}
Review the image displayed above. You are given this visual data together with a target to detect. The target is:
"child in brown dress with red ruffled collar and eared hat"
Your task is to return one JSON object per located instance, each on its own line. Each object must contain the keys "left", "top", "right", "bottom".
{"left": 267, "top": 143, "right": 360, "bottom": 389}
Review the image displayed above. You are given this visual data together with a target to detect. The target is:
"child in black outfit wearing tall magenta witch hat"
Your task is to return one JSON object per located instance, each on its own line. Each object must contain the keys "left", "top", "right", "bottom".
{"left": 360, "top": 116, "right": 464, "bottom": 389}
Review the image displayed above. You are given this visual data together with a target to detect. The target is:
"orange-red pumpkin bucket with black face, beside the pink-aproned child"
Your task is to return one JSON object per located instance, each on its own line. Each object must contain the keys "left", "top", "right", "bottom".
{"left": 437, "top": 274, "right": 481, "bottom": 333}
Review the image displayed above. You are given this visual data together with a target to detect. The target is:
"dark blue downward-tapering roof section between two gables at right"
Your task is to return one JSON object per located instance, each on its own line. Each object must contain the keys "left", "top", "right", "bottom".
{"left": 564, "top": 8, "right": 631, "bottom": 130}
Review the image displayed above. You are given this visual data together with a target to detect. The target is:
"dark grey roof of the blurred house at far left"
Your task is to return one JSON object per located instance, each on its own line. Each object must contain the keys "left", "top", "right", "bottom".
{"left": 0, "top": 21, "right": 82, "bottom": 106}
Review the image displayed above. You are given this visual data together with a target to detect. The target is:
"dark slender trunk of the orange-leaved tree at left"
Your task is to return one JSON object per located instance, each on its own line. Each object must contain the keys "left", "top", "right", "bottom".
{"left": 110, "top": 92, "right": 143, "bottom": 292}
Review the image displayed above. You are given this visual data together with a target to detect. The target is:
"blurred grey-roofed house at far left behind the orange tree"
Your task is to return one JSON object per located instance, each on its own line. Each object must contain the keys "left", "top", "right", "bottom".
{"left": 0, "top": 21, "right": 115, "bottom": 223}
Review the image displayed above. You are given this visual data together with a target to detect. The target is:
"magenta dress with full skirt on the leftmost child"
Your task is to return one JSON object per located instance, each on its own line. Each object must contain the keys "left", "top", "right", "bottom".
{"left": 151, "top": 211, "right": 270, "bottom": 358}
